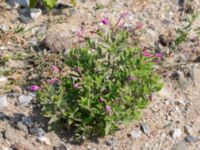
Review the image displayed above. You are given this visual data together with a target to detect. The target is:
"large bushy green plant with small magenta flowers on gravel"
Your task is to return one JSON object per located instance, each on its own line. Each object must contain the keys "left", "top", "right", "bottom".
{"left": 37, "top": 24, "right": 162, "bottom": 139}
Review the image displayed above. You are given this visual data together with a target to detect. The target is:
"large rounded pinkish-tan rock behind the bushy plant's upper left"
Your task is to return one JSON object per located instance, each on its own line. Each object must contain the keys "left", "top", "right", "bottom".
{"left": 43, "top": 31, "right": 72, "bottom": 52}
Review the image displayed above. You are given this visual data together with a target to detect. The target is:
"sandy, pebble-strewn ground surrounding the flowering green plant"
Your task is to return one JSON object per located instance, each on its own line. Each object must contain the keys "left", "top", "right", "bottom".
{"left": 0, "top": 0, "right": 200, "bottom": 150}
